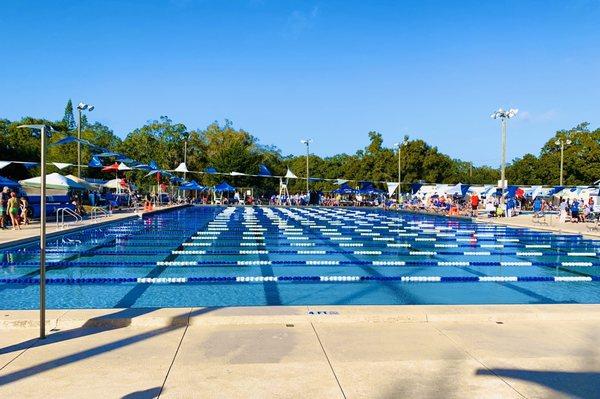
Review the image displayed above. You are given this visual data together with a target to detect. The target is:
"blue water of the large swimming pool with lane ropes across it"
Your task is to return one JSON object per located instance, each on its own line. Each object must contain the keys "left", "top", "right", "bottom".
{"left": 0, "top": 206, "right": 600, "bottom": 309}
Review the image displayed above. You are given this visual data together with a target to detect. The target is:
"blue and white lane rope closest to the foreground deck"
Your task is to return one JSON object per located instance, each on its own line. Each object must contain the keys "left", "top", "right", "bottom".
{"left": 0, "top": 276, "right": 600, "bottom": 285}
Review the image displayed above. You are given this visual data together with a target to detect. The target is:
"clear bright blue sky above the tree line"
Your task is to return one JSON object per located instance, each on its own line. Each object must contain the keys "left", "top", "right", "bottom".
{"left": 0, "top": 0, "right": 600, "bottom": 166}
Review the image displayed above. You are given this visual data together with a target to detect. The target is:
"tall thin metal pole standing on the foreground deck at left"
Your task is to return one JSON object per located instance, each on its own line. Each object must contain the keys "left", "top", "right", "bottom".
{"left": 18, "top": 125, "right": 54, "bottom": 339}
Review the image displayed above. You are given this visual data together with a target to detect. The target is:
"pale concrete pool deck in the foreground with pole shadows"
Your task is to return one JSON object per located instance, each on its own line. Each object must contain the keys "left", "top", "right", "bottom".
{"left": 0, "top": 305, "right": 600, "bottom": 398}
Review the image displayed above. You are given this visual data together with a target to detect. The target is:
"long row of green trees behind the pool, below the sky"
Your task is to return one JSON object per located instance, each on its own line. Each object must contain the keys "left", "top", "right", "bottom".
{"left": 0, "top": 101, "right": 600, "bottom": 194}
